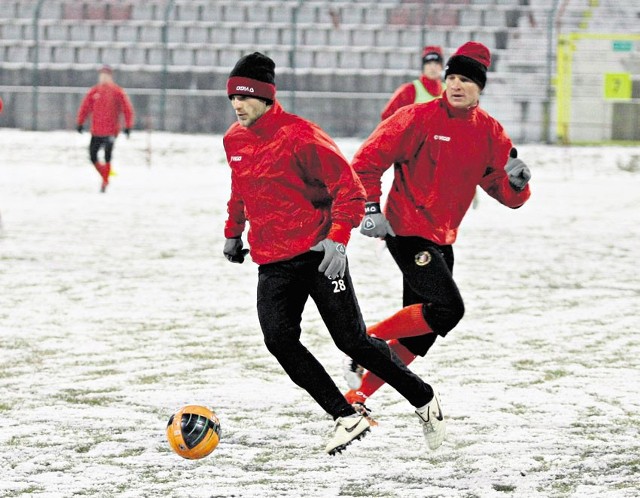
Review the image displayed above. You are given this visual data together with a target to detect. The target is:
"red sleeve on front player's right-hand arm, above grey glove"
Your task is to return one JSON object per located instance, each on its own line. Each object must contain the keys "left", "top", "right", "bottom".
{"left": 295, "top": 130, "right": 365, "bottom": 245}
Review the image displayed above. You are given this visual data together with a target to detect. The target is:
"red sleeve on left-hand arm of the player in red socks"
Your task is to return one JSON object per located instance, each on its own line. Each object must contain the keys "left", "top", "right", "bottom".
{"left": 351, "top": 105, "right": 425, "bottom": 202}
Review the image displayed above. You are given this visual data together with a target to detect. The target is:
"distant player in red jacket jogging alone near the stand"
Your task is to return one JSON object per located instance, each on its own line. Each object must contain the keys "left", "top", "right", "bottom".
{"left": 77, "top": 65, "right": 134, "bottom": 192}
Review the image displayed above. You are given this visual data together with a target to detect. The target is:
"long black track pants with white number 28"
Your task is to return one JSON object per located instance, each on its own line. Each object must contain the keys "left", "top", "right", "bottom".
{"left": 258, "top": 252, "right": 433, "bottom": 418}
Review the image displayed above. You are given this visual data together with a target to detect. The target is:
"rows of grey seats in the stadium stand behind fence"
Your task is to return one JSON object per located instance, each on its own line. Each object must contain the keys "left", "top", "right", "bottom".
{"left": 0, "top": 0, "right": 638, "bottom": 140}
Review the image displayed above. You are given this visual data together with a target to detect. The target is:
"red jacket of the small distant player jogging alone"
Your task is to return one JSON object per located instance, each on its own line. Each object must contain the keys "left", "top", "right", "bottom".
{"left": 78, "top": 83, "right": 134, "bottom": 137}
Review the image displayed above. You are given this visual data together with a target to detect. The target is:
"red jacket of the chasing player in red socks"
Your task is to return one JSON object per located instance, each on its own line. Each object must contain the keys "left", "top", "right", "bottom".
{"left": 352, "top": 94, "right": 531, "bottom": 245}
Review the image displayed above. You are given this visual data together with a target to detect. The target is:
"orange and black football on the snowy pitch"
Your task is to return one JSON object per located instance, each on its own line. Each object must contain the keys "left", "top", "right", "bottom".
{"left": 167, "top": 405, "right": 220, "bottom": 460}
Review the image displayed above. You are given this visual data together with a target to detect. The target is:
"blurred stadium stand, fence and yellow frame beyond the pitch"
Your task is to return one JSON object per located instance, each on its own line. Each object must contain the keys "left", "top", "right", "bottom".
{"left": 0, "top": 0, "right": 640, "bottom": 143}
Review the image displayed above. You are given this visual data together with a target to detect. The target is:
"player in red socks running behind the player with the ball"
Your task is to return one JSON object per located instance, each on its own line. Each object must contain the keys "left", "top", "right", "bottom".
{"left": 345, "top": 42, "right": 531, "bottom": 446}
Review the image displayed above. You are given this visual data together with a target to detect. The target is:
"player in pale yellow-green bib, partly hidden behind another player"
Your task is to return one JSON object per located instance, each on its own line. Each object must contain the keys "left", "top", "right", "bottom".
{"left": 382, "top": 45, "right": 445, "bottom": 120}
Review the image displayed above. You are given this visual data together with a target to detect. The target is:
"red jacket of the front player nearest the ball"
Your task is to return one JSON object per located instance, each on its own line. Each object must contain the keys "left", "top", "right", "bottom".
{"left": 223, "top": 101, "right": 364, "bottom": 264}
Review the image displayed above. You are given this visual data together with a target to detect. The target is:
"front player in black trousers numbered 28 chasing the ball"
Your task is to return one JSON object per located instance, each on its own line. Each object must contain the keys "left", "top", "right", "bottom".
{"left": 223, "top": 52, "right": 434, "bottom": 454}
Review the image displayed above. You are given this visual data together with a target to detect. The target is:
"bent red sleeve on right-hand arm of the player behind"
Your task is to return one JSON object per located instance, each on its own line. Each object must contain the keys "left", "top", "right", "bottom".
{"left": 480, "top": 121, "right": 531, "bottom": 209}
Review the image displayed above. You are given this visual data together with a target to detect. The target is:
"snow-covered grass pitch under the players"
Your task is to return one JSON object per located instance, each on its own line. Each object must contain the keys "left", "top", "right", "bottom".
{"left": 0, "top": 130, "right": 640, "bottom": 498}
